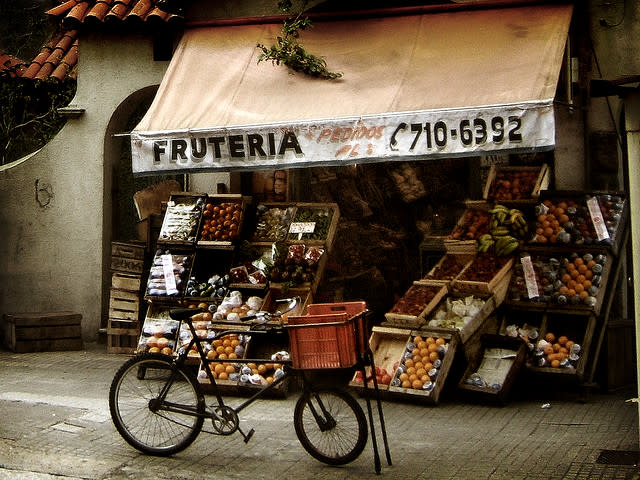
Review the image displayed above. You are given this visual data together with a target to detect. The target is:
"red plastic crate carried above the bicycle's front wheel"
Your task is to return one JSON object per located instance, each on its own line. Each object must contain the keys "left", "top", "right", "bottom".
{"left": 287, "top": 312, "right": 357, "bottom": 370}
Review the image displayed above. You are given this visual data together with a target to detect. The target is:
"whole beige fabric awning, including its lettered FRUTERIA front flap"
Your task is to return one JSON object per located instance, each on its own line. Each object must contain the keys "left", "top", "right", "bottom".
{"left": 131, "top": 5, "right": 572, "bottom": 174}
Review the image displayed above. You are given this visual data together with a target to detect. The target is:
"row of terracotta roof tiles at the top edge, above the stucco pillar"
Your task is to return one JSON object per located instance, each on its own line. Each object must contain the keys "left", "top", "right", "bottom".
{"left": 46, "top": 0, "right": 183, "bottom": 28}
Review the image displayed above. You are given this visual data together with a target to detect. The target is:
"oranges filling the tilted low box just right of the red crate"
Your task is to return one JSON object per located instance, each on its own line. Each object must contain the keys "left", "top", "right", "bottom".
{"left": 392, "top": 335, "right": 447, "bottom": 390}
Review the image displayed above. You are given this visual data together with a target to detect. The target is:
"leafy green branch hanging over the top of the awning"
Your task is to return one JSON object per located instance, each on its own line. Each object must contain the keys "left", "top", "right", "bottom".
{"left": 257, "top": 0, "right": 342, "bottom": 79}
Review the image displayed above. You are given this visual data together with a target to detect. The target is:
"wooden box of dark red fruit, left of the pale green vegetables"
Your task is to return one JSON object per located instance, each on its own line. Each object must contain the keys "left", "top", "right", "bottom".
{"left": 384, "top": 282, "right": 448, "bottom": 329}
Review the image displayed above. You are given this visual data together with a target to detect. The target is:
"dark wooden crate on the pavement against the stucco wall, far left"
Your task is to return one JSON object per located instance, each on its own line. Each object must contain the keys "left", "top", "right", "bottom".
{"left": 3, "top": 312, "right": 82, "bottom": 353}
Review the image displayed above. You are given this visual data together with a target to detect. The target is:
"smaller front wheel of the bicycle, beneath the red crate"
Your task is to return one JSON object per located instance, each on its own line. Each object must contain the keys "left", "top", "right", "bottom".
{"left": 293, "top": 387, "right": 368, "bottom": 465}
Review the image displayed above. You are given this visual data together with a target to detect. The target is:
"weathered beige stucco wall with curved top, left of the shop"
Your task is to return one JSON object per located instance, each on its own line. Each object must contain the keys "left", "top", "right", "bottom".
{"left": 0, "top": 35, "right": 167, "bottom": 340}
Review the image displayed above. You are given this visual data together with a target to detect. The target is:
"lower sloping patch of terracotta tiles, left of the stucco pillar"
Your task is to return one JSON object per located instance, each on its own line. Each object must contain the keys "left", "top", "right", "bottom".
{"left": 22, "top": 30, "right": 78, "bottom": 80}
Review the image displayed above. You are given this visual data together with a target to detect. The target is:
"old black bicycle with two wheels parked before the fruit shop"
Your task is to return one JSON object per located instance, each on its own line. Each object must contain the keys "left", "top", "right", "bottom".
{"left": 109, "top": 297, "right": 391, "bottom": 473}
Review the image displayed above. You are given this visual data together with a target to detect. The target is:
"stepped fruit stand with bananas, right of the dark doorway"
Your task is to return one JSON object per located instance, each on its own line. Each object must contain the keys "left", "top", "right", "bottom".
{"left": 352, "top": 165, "right": 628, "bottom": 404}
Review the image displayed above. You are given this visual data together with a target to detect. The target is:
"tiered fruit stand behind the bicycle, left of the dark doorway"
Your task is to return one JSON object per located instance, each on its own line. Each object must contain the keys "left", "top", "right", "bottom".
{"left": 137, "top": 192, "right": 339, "bottom": 393}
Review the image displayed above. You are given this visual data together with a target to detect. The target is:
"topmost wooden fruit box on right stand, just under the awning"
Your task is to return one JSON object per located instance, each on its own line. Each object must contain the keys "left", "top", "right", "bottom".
{"left": 482, "top": 164, "right": 551, "bottom": 203}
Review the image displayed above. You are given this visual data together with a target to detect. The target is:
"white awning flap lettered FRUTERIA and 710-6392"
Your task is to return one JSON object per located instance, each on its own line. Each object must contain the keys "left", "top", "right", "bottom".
{"left": 131, "top": 101, "right": 555, "bottom": 174}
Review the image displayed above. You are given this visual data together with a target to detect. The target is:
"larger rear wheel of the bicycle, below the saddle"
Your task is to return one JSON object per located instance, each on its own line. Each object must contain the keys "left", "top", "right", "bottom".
{"left": 109, "top": 353, "right": 206, "bottom": 456}
